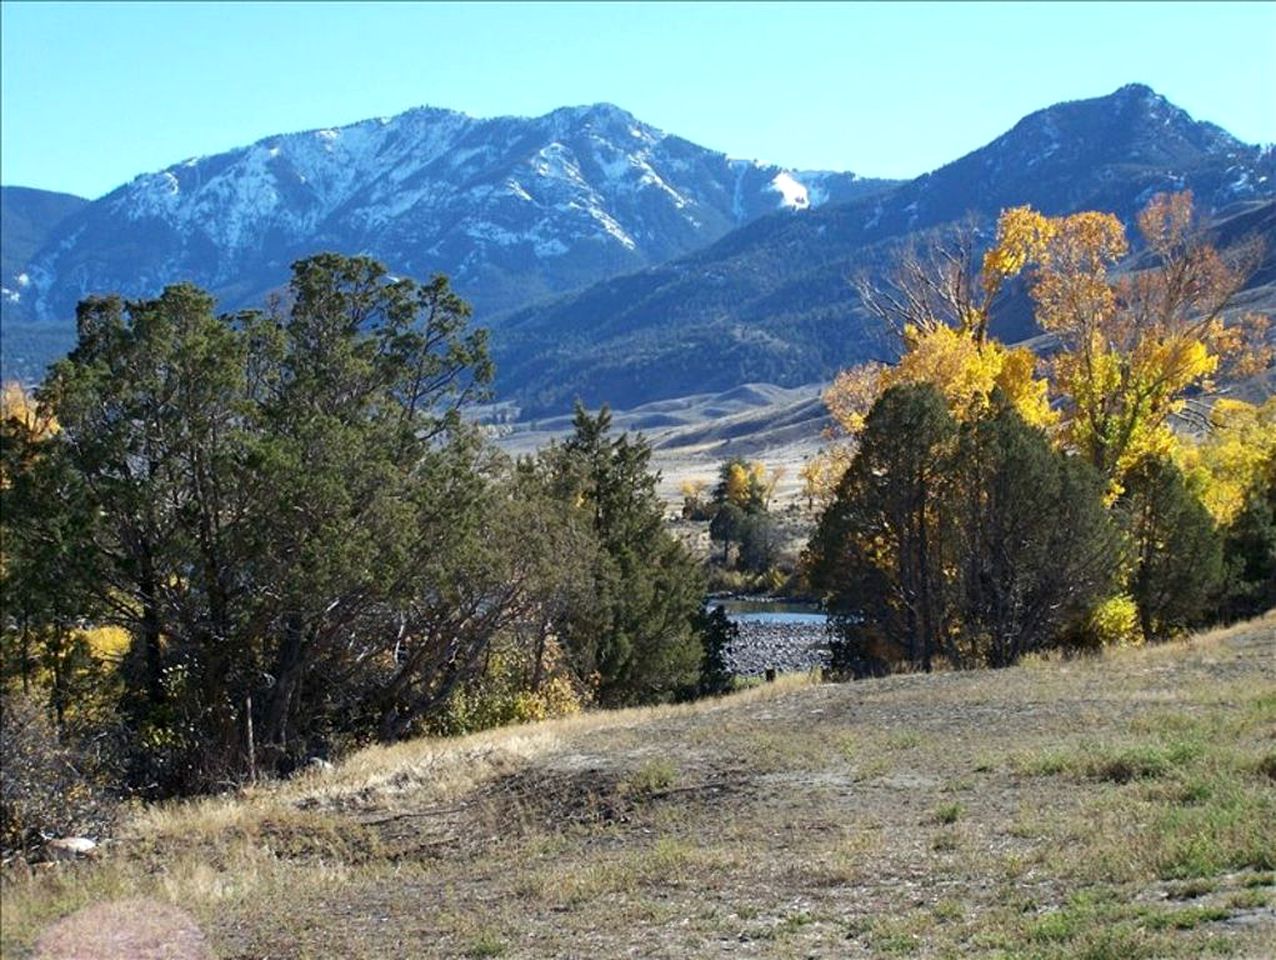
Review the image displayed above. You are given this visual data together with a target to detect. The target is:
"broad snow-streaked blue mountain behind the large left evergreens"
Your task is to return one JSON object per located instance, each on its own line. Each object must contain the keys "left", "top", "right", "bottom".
{"left": 9, "top": 103, "right": 882, "bottom": 334}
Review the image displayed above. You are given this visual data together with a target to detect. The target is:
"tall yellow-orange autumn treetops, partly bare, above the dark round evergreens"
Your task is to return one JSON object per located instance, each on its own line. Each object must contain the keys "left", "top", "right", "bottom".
{"left": 824, "top": 193, "right": 1272, "bottom": 497}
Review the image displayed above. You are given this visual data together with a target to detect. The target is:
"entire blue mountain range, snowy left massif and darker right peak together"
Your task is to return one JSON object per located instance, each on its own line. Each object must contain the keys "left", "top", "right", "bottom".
{"left": 5, "top": 84, "right": 1276, "bottom": 405}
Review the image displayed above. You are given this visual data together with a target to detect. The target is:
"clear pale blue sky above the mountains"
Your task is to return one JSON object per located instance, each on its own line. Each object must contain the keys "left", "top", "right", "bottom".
{"left": 0, "top": 0, "right": 1276, "bottom": 197}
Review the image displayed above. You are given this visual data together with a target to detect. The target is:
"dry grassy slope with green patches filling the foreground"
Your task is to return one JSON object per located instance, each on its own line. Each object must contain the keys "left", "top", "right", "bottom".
{"left": 3, "top": 615, "right": 1276, "bottom": 960}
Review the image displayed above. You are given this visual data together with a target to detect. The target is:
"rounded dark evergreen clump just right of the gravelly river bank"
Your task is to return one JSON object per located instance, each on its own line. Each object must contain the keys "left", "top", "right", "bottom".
{"left": 806, "top": 384, "right": 1122, "bottom": 673}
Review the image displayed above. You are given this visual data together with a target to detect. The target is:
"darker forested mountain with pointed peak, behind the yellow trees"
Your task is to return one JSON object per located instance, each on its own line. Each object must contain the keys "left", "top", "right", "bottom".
{"left": 494, "top": 84, "right": 1276, "bottom": 415}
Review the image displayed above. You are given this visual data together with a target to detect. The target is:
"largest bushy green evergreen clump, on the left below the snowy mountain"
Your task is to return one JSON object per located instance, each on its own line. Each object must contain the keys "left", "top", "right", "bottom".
{"left": 31, "top": 254, "right": 497, "bottom": 789}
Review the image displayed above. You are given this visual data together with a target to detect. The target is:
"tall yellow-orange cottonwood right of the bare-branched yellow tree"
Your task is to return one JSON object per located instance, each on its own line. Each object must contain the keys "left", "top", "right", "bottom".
{"left": 1030, "top": 193, "right": 1271, "bottom": 484}
